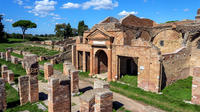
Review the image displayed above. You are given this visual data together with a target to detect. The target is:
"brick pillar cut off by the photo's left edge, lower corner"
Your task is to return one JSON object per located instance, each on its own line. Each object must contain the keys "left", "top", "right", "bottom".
{"left": 0, "top": 78, "right": 7, "bottom": 112}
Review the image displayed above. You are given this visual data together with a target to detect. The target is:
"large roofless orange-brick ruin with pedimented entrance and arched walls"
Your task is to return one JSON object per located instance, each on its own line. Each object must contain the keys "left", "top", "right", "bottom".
{"left": 72, "top": 9, "right": 200, "bottom": 93}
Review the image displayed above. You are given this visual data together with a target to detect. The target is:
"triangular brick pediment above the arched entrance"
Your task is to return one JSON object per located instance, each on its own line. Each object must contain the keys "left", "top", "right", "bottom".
{"left": 86, "top": 29, "right": 113, "bottom": 40}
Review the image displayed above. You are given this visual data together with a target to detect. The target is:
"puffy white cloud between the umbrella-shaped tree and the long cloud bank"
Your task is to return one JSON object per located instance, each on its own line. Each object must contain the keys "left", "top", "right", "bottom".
{"left": 28, "top": 0, "right": 57, "bottom": 17}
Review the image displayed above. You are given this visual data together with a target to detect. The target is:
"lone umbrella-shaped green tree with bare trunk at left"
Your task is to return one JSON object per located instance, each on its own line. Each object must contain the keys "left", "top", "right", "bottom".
{"left": 12, "top": 20, "right": 37, "bottom": 39}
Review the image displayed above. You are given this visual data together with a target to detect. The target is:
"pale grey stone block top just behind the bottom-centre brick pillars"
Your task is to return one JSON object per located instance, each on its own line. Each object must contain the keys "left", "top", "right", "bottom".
{"left": 94, "top": 79, "right": 110, "bottom": 89}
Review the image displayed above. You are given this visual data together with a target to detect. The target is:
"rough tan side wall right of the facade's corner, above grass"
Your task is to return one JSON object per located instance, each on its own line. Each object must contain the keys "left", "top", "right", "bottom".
{"left": 162, "top": 47, "right": 191, "bottom": 85}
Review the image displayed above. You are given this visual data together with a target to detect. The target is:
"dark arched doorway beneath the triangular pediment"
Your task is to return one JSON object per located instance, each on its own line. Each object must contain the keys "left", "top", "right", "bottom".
{"left": 95, "top": 50, "right": 108, "bottom": 74}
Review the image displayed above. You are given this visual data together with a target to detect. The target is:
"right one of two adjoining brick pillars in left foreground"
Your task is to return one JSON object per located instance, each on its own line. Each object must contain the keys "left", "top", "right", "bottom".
{"left": 29, "top": 76, "right": 39, "bottom": 103}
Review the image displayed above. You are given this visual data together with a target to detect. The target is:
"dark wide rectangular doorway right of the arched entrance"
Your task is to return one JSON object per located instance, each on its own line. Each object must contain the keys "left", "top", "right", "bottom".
{"left": 118, "top": 56, "right": 138, "bottom": 77}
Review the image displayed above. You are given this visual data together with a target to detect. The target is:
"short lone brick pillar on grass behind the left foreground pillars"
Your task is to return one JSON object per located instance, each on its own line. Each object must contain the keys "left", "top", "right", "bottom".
{"left": 44, "top": 63, "right": 53, "bottom": 80}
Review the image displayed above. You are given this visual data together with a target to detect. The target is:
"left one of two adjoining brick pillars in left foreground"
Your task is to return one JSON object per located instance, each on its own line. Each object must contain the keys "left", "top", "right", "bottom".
{"left": 18, "top": 75, "right": 29, "bottom": 105}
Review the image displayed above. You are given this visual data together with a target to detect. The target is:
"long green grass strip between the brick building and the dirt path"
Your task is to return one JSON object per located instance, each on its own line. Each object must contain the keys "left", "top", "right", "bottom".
{"left": 110, "top": 77, "right": 200, "bottom": 112}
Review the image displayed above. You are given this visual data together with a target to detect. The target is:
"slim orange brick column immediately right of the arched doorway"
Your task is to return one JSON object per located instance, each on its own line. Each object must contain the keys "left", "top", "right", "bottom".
{"left": 108, "top": 48, "right": 112, "bottom": 81}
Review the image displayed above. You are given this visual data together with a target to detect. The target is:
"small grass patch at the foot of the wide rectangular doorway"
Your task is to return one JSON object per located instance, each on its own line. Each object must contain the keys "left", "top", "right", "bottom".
{"left": 120, "top": 75, "right": 137, "bottom": 87}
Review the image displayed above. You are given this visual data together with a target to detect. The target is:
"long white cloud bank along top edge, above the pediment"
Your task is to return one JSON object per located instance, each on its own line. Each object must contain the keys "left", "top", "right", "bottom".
{"left": 61, "top": 0, "right": 119, "bottom": 10}
